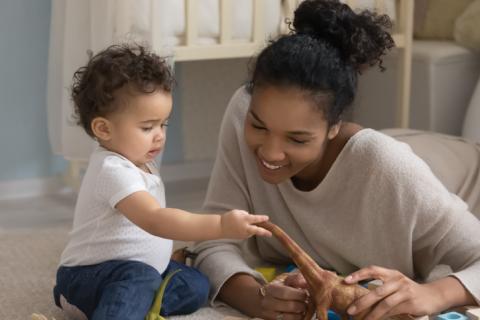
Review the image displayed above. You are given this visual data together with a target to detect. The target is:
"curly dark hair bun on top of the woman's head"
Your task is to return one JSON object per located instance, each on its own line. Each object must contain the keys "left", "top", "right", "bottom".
{"left": 293, "top": 0, "right": 394, "bottom": 70}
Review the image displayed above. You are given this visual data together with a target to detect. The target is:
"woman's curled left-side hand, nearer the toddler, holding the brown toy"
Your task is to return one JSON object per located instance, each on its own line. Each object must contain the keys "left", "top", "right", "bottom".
{"left": 259, "top": 273, "right": 308, "bottom": 320}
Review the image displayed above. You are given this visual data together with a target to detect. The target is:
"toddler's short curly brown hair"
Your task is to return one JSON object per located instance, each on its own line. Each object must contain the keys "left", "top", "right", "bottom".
{"left": 71, "top": 44, "right": 175, "bottom": 137}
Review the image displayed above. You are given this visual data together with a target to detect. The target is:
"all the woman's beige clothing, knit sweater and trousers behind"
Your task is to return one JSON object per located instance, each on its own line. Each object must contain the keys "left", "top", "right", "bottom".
{"left": 195, "top": 89, "right": 480, "bottom": 302}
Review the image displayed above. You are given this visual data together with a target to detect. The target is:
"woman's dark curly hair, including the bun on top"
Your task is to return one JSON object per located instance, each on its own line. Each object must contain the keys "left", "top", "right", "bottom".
{"left": 247, "top": 0, "right": 394, "bottom": 125}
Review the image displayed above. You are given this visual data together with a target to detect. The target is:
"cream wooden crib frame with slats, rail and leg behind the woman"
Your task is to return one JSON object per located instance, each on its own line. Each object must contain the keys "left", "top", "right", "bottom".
{"left": 150, "top": 0, "right": 414, "bottom": 128}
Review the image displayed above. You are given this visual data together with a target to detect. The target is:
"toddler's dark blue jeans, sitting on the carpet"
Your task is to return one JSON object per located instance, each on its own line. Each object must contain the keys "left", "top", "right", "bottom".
{"left": 53, "top": 260, "right": 210, "bottom": 320}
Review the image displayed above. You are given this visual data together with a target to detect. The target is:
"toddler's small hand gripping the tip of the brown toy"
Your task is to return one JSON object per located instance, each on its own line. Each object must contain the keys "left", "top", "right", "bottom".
{"left": 221, "top": 210, "right": 272, "bottom": 239}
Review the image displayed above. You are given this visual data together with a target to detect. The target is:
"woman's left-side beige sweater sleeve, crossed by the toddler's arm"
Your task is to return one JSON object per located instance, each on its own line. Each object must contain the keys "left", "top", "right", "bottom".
{"left": 194, "top": 88, "right": 265, "bottom": 305}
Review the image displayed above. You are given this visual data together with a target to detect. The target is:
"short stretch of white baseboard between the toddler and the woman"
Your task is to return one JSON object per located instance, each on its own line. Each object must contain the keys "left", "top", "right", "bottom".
{"left": 160, "top": 160, "right": 213, "bottom": 182}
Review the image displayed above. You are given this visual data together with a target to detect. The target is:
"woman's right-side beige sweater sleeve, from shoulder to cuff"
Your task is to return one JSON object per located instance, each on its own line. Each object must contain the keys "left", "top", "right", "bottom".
{"left": 366, "top": 134, "right": 480, "bottom": 303}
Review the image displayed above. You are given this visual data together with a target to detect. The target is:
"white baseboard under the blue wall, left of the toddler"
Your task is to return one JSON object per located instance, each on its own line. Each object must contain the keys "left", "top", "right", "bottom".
{"left": 0, "top": 175, "right": 65, "bottom": 200}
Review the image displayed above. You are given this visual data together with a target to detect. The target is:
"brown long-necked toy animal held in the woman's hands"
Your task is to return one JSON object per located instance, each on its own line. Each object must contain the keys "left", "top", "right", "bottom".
{"left": 258, "top": 221, "right": 370, "bottom": 320}
